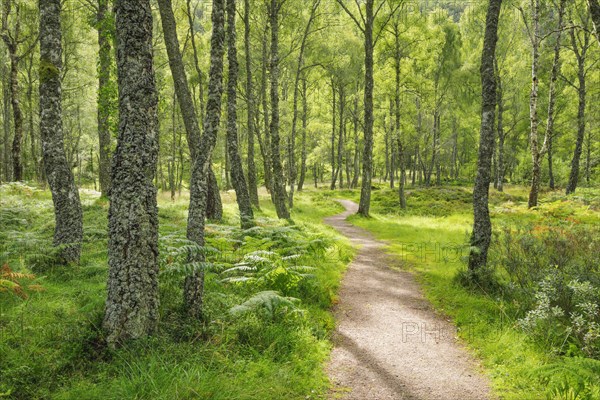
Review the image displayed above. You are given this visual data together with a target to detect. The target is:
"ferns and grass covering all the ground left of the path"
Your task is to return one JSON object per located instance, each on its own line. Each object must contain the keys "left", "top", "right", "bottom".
{"left": 0, "top": 185, "right": 352, "bottom": 399}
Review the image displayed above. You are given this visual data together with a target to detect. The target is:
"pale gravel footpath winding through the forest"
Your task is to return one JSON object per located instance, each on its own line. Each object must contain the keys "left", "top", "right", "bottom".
{"left": 325, "top": 200, "right": 490, "bottom": 400}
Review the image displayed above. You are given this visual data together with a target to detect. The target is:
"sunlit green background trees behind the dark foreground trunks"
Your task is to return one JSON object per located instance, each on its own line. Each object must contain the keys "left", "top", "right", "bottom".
{"left": 0, "top": 0, "right": 600, "bottom": 206}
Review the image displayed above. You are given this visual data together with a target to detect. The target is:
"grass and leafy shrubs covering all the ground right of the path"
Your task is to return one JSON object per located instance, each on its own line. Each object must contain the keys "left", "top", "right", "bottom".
{"left": 340, "top": 186, "right": 600, "bottom": 400}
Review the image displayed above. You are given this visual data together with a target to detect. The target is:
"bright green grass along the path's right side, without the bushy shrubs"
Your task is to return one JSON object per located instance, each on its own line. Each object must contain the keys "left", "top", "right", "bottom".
{"left": 338, "top": 187, "right": 600, "bottom": 400}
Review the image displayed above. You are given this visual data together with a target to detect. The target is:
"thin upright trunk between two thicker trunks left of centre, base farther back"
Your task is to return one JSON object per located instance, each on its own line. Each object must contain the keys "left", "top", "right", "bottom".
{"left": 244, "top": 0, "right": 260, "bottom": 208}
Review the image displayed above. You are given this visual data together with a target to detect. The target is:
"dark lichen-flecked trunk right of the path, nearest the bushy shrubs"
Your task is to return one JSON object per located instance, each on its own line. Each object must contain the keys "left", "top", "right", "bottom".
{"left": 469, "top": 0, "right": 502, "bottom": 272}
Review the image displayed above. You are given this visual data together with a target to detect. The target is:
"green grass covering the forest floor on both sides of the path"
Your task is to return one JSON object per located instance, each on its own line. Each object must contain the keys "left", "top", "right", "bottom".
{"left": 0, "top": 185, "right": 600, "bottom": 399}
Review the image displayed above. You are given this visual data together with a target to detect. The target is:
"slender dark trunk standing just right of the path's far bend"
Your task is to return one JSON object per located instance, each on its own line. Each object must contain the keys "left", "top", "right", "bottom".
{"left": 358, "top": 0, "right": 374, "bottom": 217}
